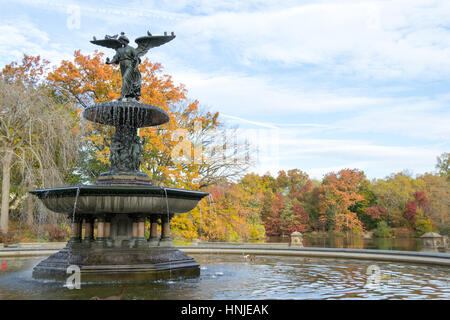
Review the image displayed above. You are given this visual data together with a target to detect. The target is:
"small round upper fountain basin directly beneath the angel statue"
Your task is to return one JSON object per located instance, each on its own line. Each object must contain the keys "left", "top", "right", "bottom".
{"left": 83, "top": 101, "right": 170, "bottom": 128}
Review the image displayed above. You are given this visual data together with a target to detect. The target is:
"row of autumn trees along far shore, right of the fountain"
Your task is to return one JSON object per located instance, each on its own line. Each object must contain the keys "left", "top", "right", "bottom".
{"left": 174, "top": 170, "right": 449, "bottom": 240}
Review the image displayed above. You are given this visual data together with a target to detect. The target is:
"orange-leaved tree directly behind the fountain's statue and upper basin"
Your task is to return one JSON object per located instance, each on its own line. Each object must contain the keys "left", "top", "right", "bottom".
{"left": 47, "top": 51, "right": 248, "bottom": 189}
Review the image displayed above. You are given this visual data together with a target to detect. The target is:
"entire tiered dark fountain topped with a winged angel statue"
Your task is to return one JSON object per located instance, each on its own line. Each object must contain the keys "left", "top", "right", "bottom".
{"left": 31, "top": 32, "right": 208, "bottom": 282}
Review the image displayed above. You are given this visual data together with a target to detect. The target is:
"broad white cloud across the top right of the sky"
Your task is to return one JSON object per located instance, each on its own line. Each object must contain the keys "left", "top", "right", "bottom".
{"left": 173, "top": 0, "right": 450, "bottom": 79}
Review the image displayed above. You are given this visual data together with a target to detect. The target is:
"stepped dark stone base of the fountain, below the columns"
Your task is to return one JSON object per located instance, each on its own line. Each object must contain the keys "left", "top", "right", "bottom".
{"left": 33, "top": 244, "right": 200, "bottom": 283}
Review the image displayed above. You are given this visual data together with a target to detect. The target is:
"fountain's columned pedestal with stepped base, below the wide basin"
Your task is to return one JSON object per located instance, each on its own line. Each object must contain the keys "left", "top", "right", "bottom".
{"left": 33, "top": 202, "right": 200, "bottom": 282}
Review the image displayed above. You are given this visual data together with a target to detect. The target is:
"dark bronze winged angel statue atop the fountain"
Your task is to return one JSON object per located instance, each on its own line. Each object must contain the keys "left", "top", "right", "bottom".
{"left": 91, "top": 31, "right": 175, "bottom": 100}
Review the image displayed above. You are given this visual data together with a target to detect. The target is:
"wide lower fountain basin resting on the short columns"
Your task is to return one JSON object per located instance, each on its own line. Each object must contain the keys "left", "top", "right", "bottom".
{"left": 30, "top": 186, "right": 208, "bottom": 215}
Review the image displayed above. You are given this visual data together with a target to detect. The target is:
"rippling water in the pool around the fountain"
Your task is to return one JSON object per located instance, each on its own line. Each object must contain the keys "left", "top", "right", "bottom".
{"left": 0, "top": 254, "right": 450, "bottom": 299}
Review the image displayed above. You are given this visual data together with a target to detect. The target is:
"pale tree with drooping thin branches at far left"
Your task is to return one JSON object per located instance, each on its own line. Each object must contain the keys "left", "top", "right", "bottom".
{"left": 0, "top": 80, "right": 77, "bottom": 233}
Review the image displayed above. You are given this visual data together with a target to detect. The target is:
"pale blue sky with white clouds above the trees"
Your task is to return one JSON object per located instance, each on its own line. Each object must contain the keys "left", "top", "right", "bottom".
{"left": 0, "top": 0, "right": 450, "bottom": 178}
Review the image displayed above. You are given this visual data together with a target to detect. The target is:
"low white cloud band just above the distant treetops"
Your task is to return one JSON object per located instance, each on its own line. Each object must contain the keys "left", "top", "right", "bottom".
{"left": 246, "top": 129, "right": 442, "bottom": 179}
